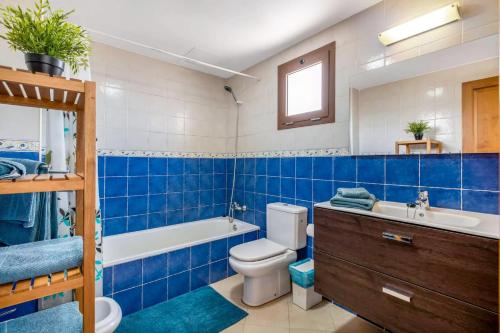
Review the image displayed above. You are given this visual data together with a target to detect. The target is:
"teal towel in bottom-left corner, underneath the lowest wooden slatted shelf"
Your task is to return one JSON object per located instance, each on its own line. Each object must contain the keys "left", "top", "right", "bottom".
{"left": 0, "top": 302, "right": 83, "bottom": 333}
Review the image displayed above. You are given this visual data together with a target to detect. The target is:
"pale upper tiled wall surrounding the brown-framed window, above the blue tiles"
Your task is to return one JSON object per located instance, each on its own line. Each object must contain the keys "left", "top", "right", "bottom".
{"left": 228, "top": 0, "right": 498, "bottom": 152}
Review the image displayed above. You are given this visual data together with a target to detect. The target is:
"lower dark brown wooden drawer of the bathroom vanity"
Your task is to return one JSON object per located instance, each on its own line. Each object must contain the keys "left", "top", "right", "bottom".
{"left": 314, "top": 252, "right": 498, "bottom": 333}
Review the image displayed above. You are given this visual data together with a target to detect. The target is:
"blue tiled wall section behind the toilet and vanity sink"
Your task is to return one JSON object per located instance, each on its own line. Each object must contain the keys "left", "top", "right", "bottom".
{"left": 227, "top": 154, "right": 499, "bottom": 258}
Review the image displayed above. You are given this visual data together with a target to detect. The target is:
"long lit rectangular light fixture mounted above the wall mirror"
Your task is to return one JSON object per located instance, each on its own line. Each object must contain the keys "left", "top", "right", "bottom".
{"left": 378, "top": 2, "right": 460, "bottom": 46}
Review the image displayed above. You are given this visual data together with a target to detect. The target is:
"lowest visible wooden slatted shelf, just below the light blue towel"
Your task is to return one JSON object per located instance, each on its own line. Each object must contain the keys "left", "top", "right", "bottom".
{"left": 0, "top": 267, "right": 83, "bottom": 309}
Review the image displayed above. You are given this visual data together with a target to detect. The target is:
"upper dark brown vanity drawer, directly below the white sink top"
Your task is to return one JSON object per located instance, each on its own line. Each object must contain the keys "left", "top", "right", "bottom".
{"left": 314, "top": 209, "right": 498, "bottom": 312}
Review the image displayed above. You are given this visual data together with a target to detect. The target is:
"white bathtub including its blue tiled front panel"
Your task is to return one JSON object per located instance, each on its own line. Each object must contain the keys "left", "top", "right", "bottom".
{"left": 102, "top": 217, "right": 259, "bottom": 315}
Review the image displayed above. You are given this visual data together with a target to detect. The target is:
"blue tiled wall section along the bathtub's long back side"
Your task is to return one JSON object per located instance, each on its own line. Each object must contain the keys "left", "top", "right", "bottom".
{"left": 98, "top": 156, "right": 228, "bottom": 236}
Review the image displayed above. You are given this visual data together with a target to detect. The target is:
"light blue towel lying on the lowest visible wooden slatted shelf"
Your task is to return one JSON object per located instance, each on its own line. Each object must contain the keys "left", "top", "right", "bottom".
{"left": 0, "top": 236, "right": 83, "bottom": 284}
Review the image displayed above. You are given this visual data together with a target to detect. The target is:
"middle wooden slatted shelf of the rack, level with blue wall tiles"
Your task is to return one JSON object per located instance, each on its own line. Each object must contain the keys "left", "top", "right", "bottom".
{"left": 0, "top": 173, "right": 84, "bottom": 194}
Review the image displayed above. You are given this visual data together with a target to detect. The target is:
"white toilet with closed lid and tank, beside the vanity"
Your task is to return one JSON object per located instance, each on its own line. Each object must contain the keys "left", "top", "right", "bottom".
{"left": 229, "top": 203, "right": 307, "bottom": 306}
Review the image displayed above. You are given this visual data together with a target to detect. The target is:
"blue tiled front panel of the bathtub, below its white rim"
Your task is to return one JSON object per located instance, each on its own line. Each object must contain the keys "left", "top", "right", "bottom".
{"left": 103, "top": 230, "right": 258, "bottom": 315}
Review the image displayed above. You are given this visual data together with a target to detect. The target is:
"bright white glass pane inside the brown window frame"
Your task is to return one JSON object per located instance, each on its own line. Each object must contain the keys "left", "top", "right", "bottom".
{"left": 286, "top": 62, "right": 323, "bottom": 116}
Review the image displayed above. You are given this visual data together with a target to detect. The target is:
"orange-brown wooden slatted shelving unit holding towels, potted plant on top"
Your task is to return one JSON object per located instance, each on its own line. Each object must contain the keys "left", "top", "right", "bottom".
{"left": 0, "top": 66, "right": 96, "bottom": 333}
